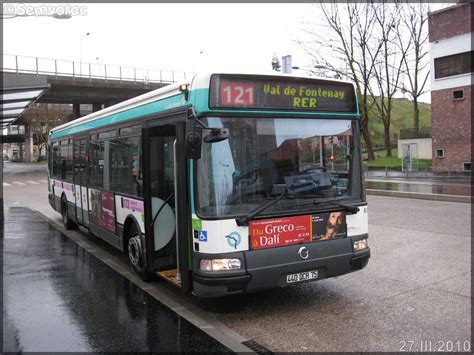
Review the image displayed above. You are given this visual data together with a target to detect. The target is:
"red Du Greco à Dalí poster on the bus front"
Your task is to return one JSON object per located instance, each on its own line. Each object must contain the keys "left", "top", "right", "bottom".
{"left": 249, "top": 216, "right": 312, "bottom": 249}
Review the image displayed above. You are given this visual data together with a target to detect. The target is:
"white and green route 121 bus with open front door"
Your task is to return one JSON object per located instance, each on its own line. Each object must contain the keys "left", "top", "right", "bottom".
{"left": 48, "top": 73, "right": 370, "bottom": 297}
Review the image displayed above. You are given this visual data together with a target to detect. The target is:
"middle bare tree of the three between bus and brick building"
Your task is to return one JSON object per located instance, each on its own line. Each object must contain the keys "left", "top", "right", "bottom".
{"left": 368, "top": 3, "right": 410, "bottom": 157}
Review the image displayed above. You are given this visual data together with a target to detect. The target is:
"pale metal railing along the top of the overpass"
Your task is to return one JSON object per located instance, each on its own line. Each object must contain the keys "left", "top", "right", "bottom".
{"left": 2, "top": 54, "right": 195, "bottom": 84}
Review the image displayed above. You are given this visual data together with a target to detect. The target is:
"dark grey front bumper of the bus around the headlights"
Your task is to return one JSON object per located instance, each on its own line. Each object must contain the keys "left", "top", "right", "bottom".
{"left": 193, "top": 235, "right": 370, "bottom": 297}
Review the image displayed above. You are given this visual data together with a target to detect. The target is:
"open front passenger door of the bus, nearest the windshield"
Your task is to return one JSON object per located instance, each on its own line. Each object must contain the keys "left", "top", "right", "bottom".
{"left": 143, "top": 120, "right": 191, "bottom": 292}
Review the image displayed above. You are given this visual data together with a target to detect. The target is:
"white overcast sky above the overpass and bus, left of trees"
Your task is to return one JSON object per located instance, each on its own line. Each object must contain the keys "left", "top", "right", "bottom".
{"left": 3, "top": 3, "right": 456, "bottom": 101}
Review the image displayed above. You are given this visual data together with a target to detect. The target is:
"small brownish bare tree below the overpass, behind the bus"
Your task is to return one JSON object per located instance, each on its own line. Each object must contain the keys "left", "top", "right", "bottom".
{"left": 24, "top": 104, "right": 70, "bottom": 155}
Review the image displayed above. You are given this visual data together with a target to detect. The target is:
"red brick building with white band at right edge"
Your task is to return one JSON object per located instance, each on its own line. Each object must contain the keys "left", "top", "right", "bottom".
{"left": 428, "top": 2, "right": 474, "bottom": 171}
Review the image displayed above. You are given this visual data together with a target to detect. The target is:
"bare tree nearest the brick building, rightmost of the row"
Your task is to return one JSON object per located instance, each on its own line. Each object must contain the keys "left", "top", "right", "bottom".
{"left": 397, "top": 1, "right": 430, "bottom": 133}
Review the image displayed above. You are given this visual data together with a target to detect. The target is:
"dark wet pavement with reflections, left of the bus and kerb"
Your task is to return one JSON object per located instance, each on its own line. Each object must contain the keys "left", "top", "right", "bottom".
{"left": 3, "top": 208, "right": 228, "bottom": 352}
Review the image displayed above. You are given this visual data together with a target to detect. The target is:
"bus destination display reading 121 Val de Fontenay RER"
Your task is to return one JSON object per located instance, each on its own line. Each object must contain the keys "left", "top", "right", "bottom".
{"left": 209, "top": 74, "right": 357, "bottom": 113}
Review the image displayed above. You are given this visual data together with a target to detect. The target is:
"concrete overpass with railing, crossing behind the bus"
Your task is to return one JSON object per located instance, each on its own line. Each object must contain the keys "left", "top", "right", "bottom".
{"left": 1, "top": 54, "right": 193, "bottom": 124}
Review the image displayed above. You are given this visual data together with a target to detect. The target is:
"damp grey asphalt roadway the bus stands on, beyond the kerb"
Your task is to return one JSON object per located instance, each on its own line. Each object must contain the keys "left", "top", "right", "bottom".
{"left": 4, "top": 162, "right": 472, "bottom": 352}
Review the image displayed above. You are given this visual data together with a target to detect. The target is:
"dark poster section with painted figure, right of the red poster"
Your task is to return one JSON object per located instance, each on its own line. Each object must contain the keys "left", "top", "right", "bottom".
{"left": 312, "top": 212, "right": 347, "bottom": 240}
